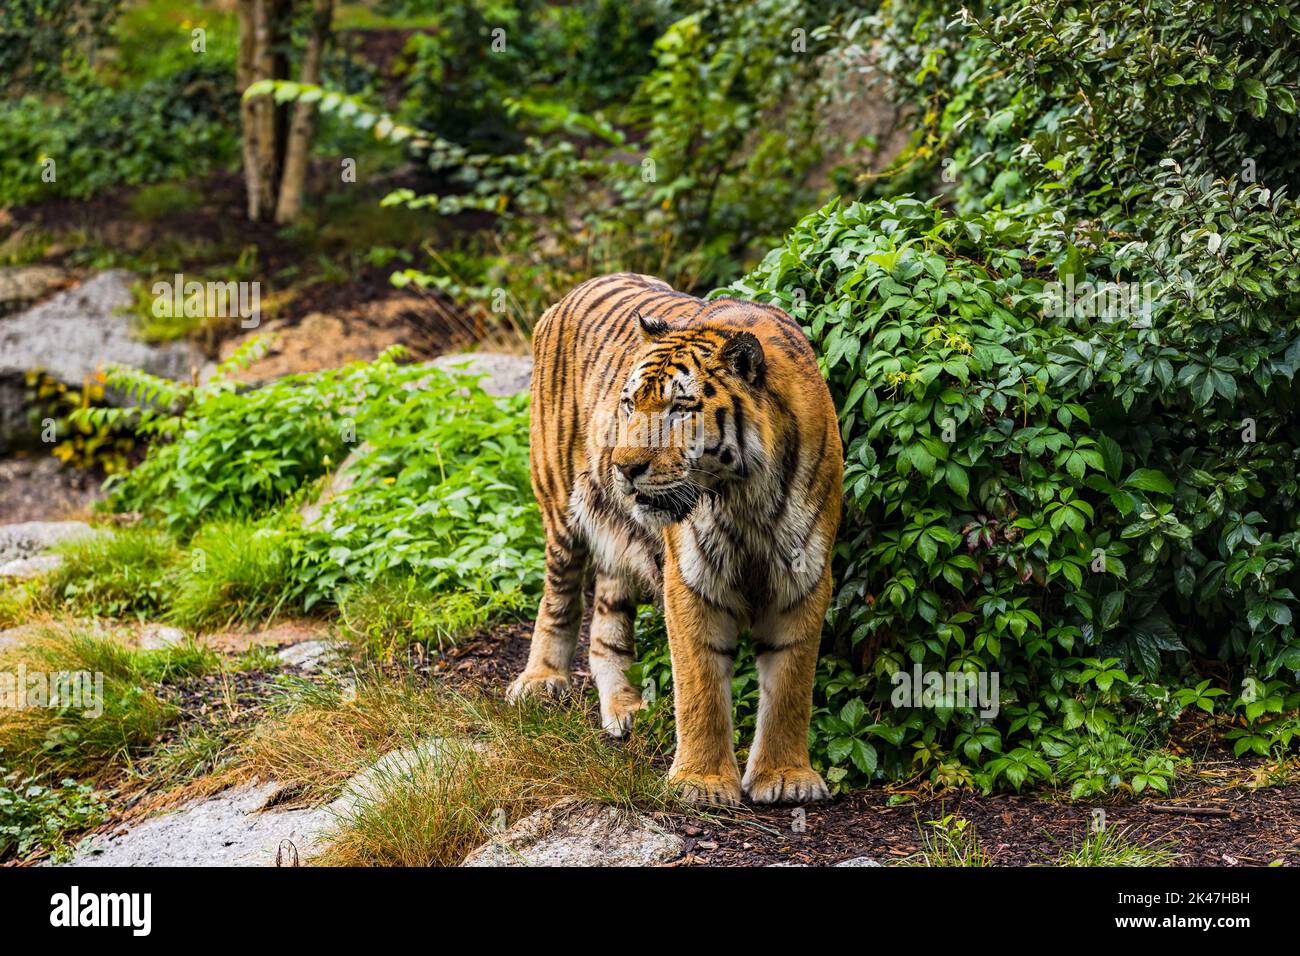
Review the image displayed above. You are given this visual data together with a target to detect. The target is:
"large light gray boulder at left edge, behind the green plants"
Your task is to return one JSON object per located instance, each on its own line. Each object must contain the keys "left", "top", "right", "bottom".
{"left": 0, "top": 269, "right": 195, "bottom": 447}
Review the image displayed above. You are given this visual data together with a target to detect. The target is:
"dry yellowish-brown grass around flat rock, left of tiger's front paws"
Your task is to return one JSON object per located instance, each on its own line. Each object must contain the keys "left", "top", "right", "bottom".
{"left": 247, "top": 679, "right": 677, "bottom": 866}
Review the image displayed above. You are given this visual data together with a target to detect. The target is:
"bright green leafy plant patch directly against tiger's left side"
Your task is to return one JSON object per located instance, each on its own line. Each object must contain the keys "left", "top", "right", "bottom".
{"left": 295, "top": 368, "right": 542, "bottom": 607}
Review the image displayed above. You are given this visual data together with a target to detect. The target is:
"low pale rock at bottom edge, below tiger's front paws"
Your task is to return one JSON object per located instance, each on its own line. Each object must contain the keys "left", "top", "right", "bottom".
{"left": 462, "top": 801, "right": 685, "bottom": 866}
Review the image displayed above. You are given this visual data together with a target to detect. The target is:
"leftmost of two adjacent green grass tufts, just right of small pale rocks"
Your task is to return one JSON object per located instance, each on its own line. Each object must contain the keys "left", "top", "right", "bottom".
{"left": 47, "top": 528, "right": 179, "bottom": 619}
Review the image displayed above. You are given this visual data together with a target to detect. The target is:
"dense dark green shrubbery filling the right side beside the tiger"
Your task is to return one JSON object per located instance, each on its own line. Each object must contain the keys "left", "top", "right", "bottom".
{"left": 724, "top": 0, "right": 1300, "bottom": 796}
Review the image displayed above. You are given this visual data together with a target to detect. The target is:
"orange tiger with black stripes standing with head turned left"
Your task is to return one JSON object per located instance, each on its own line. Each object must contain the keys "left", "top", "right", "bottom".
{"left": 507, "top": 273, "right": 844, "bottom": 805}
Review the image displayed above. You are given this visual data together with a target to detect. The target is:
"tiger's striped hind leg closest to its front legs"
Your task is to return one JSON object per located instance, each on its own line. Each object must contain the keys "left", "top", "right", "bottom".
{"left": 590, "top": 571, "right": 645, "bottom": 737}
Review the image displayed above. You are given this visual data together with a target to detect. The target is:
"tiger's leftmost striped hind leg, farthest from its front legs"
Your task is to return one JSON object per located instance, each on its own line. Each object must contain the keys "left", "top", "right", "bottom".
{"left": 506, "top": 523, "right": 589, "bottom": 702}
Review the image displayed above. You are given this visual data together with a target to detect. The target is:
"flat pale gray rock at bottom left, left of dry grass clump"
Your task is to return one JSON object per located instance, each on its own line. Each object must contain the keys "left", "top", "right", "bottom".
{"left": 66, "top": 782, "right": 338, "bottom": 866}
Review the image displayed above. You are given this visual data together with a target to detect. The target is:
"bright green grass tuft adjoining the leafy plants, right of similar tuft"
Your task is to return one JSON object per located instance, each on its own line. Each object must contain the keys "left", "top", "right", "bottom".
{"left": 168, "top": 523, "right": 294, "bottom": 631}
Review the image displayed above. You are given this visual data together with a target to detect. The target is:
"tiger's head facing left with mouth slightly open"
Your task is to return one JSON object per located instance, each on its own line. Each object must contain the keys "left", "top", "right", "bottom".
{"left": 608, "top": 313, "right": 767, "bottom": 528}
